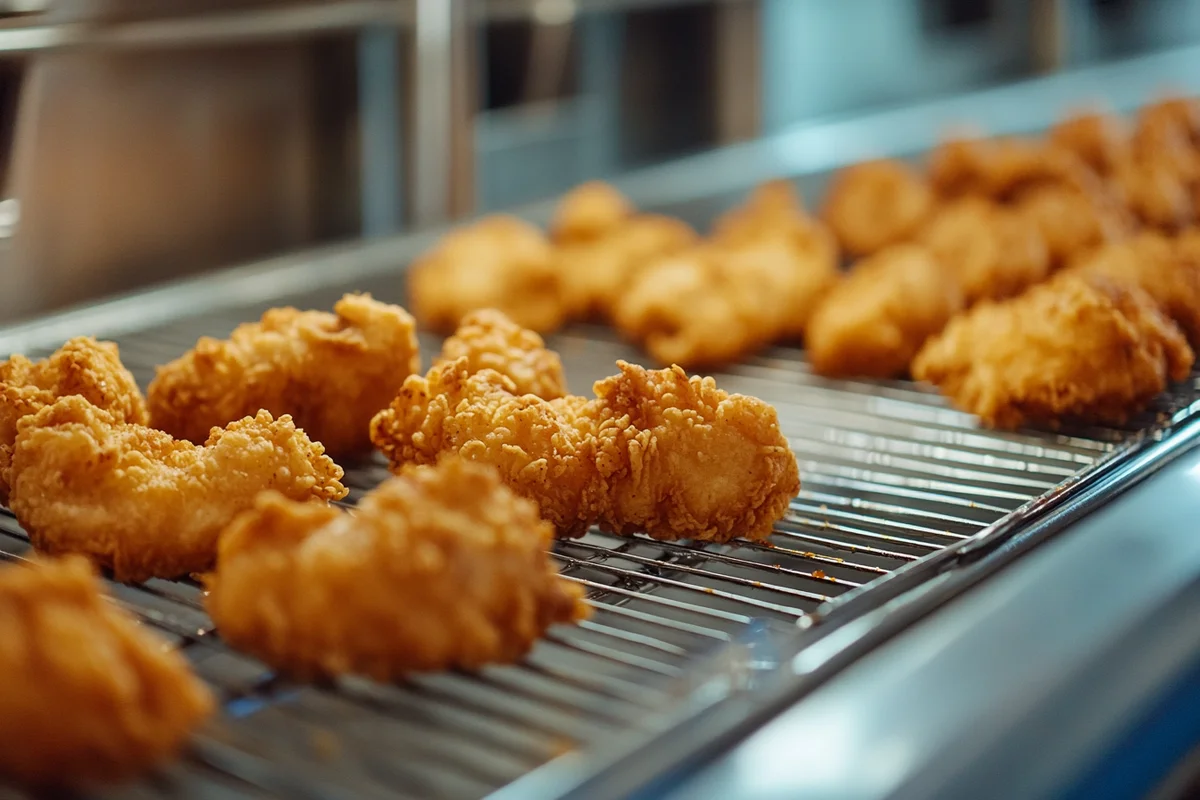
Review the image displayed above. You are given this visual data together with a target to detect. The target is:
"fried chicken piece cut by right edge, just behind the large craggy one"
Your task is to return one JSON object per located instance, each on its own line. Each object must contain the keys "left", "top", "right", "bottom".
{"left": 1069, "top": 231, "right": 1200, "bottom": 345}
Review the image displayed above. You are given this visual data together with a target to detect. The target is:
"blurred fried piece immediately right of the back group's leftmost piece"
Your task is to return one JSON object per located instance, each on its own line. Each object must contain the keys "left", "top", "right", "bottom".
{"left": 558, "top": 213, "right": 697, "bottom": 319}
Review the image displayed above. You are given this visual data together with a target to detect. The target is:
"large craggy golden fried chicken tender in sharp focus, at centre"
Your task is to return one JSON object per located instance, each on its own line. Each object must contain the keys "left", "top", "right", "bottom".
{"left": 371, "top": 359, "right": 799, "bottom": 542}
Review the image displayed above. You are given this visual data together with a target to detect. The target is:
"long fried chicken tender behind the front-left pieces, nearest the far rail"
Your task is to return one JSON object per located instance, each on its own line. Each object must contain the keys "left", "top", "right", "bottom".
{"left": 146, "top": 294, "right": 421, "bottom": 455}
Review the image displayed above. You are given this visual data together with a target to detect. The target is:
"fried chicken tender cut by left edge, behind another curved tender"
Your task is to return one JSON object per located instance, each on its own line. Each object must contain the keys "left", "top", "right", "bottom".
{"left": 0, "top": 336, "right": 146, "bottom": 503}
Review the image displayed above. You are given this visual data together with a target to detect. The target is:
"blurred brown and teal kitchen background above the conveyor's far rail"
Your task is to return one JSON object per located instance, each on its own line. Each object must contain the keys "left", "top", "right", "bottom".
{"left": 0, "top": 0, "right": 1200, "bottom": 323}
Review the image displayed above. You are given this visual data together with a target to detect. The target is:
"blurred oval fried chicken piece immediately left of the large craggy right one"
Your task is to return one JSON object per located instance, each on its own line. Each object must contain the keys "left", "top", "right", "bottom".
{"left": 805, "top": 245, "right": 964, "bottom": 378}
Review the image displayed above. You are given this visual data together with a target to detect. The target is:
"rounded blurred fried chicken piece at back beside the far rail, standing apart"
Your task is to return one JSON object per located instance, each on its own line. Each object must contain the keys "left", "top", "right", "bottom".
{"left": 821, "top": 161, "right": 934, "bottom": 255}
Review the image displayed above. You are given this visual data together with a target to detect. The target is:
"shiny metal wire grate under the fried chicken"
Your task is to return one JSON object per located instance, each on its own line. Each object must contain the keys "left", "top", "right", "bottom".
{"left": 0, "top": 296, "right": 1194, "bottom": 798}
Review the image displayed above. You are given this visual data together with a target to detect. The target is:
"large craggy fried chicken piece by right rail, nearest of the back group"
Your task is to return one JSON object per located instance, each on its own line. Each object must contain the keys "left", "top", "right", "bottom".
{"left": 912, "top": 275, "right": 1194, "bottom": 428}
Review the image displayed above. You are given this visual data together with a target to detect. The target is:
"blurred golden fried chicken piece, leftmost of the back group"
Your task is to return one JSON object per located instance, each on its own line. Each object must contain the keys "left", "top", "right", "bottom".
{"left": 408, "top": 215, "right": 566, "bottom": 333}
